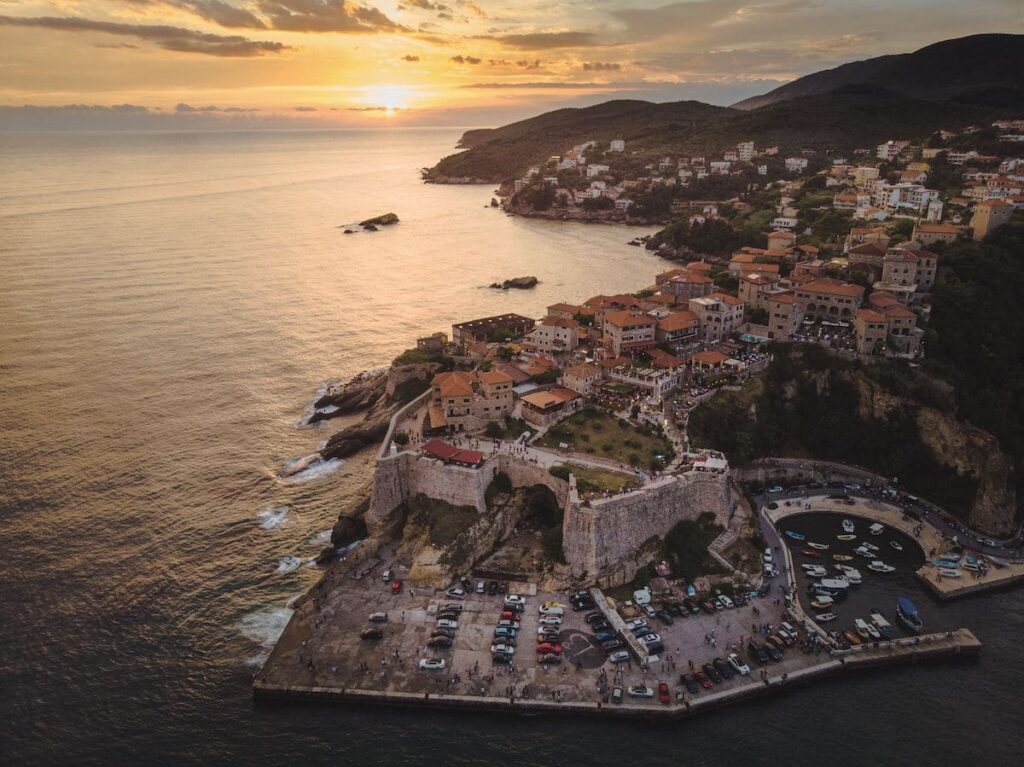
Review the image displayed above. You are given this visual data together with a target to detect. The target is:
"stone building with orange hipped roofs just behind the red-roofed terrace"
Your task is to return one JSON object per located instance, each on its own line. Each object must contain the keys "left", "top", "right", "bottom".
{"left": 427, "top": 371, "right": 512, "bottom": 432}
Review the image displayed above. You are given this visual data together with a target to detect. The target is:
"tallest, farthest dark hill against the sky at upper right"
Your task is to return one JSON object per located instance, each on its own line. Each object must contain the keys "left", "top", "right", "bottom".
{"left": 733, "top": 35, "right": 1024, "bottom": 110}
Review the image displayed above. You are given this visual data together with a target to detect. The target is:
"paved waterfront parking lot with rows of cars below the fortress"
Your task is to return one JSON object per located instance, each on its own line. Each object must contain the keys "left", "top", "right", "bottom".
{"left": 256, "top": 561, "right": 831, "bottom": 706}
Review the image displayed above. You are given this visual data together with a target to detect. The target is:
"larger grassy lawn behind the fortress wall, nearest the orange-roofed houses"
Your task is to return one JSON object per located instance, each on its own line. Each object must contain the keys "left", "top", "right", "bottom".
{"left": 537, "top": 408, "right": 672, "bottom": 468}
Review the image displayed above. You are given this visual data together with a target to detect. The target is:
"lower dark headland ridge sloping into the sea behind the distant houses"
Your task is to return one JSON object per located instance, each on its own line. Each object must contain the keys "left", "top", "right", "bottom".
{"left": 425, "top": 85, "right": 1002, "bottom": 183}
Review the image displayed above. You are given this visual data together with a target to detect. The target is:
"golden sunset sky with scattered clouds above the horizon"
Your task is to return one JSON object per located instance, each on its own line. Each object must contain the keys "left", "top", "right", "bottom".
{"left": 0, "top": 0, "right": 1024, "bottom": 128}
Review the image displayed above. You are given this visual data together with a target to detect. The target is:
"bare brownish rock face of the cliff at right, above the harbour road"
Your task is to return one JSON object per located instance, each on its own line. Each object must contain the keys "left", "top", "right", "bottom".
{"left": 856, "top": 376, "right": 1018, "bottom": 536}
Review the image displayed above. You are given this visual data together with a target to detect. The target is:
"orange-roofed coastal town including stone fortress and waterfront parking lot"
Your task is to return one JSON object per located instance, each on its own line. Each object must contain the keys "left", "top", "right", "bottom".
{"left": 254, "top": 115, "right": 1024, "bottom": 716}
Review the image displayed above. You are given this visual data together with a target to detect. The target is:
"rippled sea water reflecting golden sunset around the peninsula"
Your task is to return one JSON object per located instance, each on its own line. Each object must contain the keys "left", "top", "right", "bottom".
{"left": 0, "top": 131, "right": 1024, "bottom": 765}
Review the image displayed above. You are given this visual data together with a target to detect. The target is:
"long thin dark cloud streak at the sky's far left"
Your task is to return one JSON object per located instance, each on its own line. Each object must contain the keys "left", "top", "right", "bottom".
{"left": 0, "top": 16, "right": 289, "bottom": 57}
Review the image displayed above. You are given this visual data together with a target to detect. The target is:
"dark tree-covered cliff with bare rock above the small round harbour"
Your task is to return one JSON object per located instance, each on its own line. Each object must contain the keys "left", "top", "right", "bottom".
{"left": 689, "top": 344, "right": 1019, "bottom": 536}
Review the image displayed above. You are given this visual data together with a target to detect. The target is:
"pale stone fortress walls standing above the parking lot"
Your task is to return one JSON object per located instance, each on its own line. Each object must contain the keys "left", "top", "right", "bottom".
{"left": 365, "top": 391, "right": 732, "bottom": 584}
